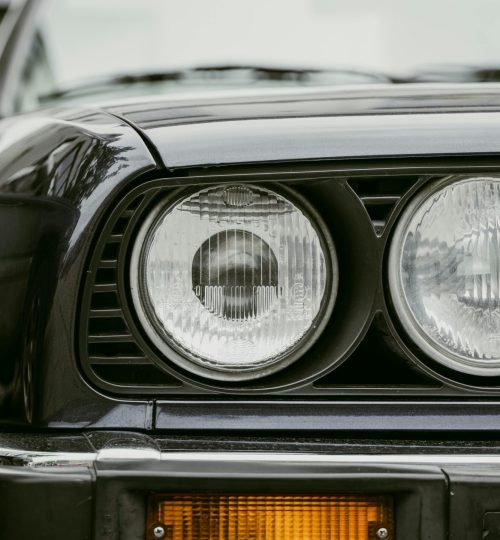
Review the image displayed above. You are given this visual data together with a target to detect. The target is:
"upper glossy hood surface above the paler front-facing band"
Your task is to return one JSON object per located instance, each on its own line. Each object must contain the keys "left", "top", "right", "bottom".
{"left": 109, "top": 84, "right": 500, "bottom": 131}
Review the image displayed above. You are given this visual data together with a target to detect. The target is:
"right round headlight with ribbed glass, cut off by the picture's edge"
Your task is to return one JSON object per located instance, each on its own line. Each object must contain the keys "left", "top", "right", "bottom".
{"left": 389, "top": 177, "right": 500, "bottom": 376}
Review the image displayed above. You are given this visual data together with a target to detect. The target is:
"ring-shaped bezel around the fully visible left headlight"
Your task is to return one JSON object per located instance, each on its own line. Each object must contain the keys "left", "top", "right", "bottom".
{"left": 129, "top": 182, "right": 339, "bottom": 383}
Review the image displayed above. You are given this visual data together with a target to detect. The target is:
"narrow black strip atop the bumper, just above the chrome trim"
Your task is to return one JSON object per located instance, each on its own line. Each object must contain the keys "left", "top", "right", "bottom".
{"left": 6, "top": 429, "right": 500, "bottom": 456}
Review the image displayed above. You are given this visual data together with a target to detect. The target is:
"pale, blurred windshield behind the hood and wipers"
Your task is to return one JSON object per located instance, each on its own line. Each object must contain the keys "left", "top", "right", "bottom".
{"left": 11, "top": 0, "right": 500, "bottom": 109}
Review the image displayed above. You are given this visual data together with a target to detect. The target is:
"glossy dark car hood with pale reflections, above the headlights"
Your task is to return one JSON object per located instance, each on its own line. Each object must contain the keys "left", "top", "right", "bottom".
{"left": 79, "top": 84, "right": 500, "bottom": 169}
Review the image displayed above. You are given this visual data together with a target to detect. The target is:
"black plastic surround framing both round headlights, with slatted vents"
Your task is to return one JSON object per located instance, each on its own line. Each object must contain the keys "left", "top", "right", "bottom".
{"left": 77, "top": 163, "right": 500, "bottom": 400}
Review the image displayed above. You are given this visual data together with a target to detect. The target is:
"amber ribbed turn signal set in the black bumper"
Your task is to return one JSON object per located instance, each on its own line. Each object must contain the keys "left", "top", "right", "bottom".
{"left": 148, "top": 493, "right": 394, "bottom": 540}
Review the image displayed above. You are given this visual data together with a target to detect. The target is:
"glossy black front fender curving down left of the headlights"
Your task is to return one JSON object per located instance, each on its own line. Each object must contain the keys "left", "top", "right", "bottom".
{"left": 0, "top": 105, "right": 155, "bottom": 428}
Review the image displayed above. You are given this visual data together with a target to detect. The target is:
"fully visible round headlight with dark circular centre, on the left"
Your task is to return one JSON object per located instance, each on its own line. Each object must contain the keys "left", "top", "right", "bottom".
{"left": 131, "top": 185, "right": 338, "bottom": 380}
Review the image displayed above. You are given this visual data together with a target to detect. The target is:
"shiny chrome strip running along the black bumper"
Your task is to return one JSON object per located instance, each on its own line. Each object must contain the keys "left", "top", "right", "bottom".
{"left": 0, "top": 448, "right": 500, "bottom": 468}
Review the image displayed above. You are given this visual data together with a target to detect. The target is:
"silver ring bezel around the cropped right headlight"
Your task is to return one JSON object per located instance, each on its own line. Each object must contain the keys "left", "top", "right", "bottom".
{"left": 386, "top": 173, "right": 500, "bottom": 381}
